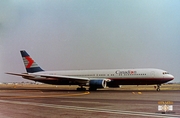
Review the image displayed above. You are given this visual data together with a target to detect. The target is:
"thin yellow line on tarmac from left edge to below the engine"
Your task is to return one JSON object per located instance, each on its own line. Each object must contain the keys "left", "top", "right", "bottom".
{"left": 0, "top": 92, "right": 90, "bottom": 99}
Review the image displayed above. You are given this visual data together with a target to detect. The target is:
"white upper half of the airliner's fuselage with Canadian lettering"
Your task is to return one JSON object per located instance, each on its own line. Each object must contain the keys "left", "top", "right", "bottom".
{"left": 35, "top": 69, "right": 174, "bottom": 79}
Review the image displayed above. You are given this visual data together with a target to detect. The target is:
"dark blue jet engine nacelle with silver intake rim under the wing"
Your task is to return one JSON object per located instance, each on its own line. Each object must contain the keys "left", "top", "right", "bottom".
{"left": 89, "top": 79, "right": 107, "bottom": 88}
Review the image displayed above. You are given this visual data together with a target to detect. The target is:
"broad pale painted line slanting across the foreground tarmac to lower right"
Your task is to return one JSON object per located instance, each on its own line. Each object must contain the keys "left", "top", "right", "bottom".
{"left": 0, "top": 100, "right": 180, "bottom": 118}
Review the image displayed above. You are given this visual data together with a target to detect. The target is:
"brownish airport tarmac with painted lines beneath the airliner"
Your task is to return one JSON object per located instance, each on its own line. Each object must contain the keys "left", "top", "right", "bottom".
{"left": 0, "top": 84, "right": 180, "bottom": 118}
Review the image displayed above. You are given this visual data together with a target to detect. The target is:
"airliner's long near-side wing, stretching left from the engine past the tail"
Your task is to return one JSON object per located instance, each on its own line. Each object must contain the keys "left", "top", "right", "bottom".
{"left": 6, "top": 73, "right": 89, "bottom": 84}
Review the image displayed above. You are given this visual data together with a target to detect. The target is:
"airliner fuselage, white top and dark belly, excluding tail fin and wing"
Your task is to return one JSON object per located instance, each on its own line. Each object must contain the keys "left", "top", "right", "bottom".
{"left": 33, "top": 68, "right": 174, "bottom": 86}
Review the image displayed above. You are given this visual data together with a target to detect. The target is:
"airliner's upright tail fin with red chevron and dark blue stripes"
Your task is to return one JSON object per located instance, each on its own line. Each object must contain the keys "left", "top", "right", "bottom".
{"left": 20, "top": 50, "right": 44, "bottom": 73}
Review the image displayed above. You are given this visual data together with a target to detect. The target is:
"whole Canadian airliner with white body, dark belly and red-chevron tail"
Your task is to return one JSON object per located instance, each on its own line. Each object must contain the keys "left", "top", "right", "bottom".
{"left": 6, "top": 50, "right": 174, "bottom": 91}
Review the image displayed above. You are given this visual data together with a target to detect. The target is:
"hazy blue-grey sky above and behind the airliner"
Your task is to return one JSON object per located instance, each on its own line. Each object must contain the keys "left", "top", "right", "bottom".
{"left": 0, "top": 0, "right": 180, "bottom": 82}
